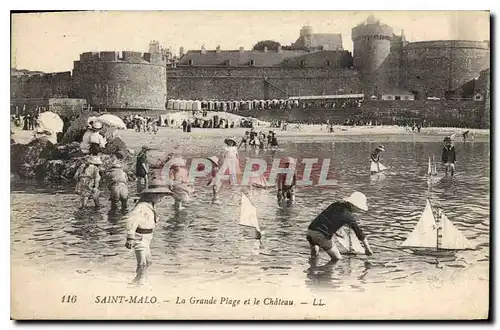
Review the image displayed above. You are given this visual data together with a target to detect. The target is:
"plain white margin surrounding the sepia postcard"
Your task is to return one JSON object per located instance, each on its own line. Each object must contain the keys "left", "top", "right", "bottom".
{"left": 0, "top": 0, "right": 500, "bottom": 330}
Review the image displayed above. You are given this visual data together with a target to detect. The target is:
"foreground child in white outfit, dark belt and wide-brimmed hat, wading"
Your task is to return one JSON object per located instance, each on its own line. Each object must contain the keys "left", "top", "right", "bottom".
{"left": 125, "top": 180, "right": 172, "bottom": 282}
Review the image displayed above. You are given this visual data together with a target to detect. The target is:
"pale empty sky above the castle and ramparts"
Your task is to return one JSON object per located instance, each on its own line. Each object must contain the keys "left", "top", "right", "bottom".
{"left": 11, "top": 11, "right": 490, "bottom": 72}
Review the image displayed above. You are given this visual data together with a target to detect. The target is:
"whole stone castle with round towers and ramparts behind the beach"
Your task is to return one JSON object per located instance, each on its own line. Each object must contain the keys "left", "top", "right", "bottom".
{"left": 11, "top": 16, "right": 490, "bottom": 110}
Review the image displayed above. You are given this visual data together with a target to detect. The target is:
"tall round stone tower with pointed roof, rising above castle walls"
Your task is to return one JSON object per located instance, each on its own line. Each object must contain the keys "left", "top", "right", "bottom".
{"left": 351, "top": 15, "right": 393, "bottom": 75}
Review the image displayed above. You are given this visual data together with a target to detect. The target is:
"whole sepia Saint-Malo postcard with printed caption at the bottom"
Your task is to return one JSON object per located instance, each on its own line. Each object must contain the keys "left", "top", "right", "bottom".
{"left": 10, "top": 10, "right": 492, "bottom": 320}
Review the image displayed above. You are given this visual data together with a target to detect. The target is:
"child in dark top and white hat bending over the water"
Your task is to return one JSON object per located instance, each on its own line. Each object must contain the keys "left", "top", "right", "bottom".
{"left": 306, "top": 191, "right": 373, "bottom": 260}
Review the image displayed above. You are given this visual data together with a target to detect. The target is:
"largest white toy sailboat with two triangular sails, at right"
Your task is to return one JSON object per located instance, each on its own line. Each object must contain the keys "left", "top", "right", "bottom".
{"left": 401, "top": 200, "right": 475, "bottom": 256}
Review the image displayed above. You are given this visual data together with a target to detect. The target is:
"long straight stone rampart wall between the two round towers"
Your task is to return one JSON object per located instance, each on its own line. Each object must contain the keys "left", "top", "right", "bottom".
{"left": 168, "top": 67, "right": 360, "bottom": 100}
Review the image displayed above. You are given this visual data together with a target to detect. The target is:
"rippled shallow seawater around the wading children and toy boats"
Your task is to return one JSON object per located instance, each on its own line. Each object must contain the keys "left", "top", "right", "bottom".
{"left": 11, "top": 139, "right": 490, "bottom": 291}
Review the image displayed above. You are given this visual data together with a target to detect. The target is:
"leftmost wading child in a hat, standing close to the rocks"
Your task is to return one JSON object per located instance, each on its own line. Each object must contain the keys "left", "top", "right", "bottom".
{"left": 75, "top": 156, "right": 102, "bottom": 209}
